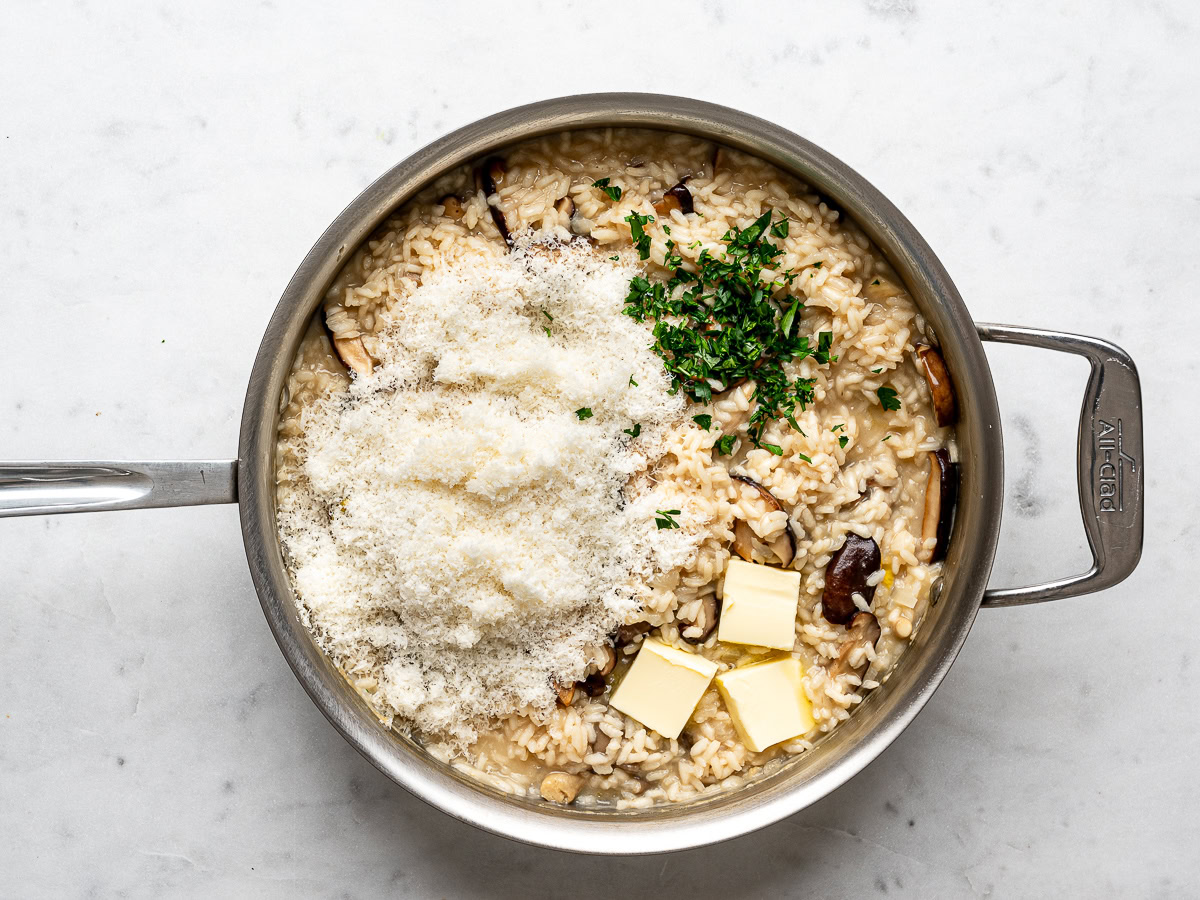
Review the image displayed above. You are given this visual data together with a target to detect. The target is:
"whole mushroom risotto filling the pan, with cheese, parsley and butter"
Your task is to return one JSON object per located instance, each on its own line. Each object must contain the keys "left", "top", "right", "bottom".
{"left": 276, "top": 130, "right": 958, "bottom": 808}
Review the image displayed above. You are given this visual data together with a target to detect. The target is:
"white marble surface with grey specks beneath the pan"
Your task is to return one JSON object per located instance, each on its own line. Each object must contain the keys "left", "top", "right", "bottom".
{"left": 0, "top": 0, "right": 1200, "bottom": 898}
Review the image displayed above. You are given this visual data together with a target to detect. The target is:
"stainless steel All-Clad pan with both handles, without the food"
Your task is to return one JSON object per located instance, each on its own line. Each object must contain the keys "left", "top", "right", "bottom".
{"left": 0, "top": 94, "right": 1142, "bottom": 853}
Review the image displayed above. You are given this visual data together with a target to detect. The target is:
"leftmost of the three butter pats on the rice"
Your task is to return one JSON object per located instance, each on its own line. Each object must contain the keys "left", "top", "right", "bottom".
{"left": 610, "top": 638, "right": 718, "bottom": 738}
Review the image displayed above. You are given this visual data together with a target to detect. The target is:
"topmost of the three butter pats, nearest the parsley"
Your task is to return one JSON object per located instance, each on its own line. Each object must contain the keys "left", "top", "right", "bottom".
{"left": 716, "top": 559, "right": 800, "bottom": 650}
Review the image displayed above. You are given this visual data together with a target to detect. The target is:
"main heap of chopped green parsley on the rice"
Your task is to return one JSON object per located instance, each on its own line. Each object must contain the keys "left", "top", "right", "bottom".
{"left": 625, "top": 211, "right": 836, "bottom": 455}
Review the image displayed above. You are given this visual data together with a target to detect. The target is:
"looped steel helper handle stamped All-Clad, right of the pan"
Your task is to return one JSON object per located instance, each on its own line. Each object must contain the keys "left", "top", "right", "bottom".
{"left": 978, "top": 324, "right": 1142, "bottom": 606}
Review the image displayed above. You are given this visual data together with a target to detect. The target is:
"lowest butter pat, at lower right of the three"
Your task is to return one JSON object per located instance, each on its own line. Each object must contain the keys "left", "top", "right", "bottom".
{"left": 716, "top": 656, "right": 815, "bottom": 754}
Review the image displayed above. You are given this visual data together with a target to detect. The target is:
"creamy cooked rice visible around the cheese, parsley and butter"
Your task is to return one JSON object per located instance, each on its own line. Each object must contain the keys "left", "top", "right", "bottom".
{"left": 276, "top": 130, "right": 953, "bottom": 806}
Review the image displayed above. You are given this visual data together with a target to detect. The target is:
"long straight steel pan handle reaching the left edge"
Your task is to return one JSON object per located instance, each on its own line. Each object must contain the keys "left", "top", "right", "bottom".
{"left": 0, "top": 460, "right": 238, "bottom": 518}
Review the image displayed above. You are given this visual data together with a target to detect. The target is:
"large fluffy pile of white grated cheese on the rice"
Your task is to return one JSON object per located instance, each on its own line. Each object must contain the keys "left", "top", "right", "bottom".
{"left": 278, "top": 244, "right": 701, "bottom": 744}
